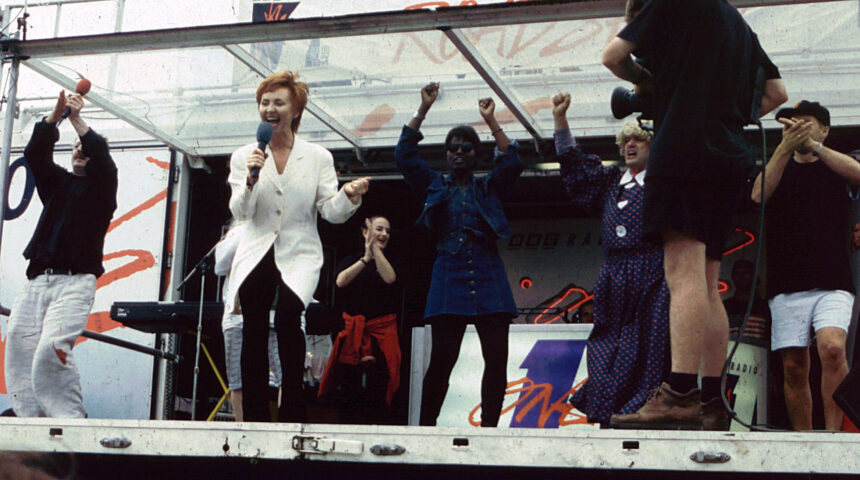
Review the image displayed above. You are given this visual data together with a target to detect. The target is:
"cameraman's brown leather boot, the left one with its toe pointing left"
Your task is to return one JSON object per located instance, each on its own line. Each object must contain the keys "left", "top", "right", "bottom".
{"left": 609, "top": 382, "right": 702, "bottom": 430}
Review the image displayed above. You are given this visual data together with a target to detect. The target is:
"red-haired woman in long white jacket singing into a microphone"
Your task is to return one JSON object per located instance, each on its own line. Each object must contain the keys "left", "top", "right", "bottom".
{"left": 223, "top": 71, "right": 370, "bottom": 422}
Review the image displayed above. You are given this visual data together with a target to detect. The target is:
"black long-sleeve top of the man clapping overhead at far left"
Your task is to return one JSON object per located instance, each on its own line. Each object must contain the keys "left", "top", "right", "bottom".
{"left": 24, "top": 120, "right": 117, "bottom": 279}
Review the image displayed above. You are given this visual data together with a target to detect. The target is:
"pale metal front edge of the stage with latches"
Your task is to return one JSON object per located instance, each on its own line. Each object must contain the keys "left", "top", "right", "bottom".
{"left": 0, "top": 417, "right": 860, "bottom": 476}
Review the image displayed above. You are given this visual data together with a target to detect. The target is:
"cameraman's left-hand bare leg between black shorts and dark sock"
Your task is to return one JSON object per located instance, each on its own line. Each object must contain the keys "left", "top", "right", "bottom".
{"left": 663, "top": 232, "right": 708, "bottom": 375}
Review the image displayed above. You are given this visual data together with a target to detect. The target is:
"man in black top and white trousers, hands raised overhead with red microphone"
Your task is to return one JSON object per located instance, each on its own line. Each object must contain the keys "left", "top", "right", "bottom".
{"left": 5, "top": 92, "right": 117, "bottom": 418}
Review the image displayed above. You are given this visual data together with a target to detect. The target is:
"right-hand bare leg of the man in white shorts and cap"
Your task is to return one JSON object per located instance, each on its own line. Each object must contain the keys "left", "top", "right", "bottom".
{"left": 815, "top": 327, "right": 848, "bottom": 431}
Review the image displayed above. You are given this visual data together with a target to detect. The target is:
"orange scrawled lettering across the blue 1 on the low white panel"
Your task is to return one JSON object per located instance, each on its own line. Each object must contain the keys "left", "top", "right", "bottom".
{"left": 468, "top": 377, "right": 590, "bottom": 428}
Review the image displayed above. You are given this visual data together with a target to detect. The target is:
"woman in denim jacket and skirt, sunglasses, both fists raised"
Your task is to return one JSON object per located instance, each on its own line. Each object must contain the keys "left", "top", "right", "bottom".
{"left": 394, "top": 83, "right": 523, "bottom": 427}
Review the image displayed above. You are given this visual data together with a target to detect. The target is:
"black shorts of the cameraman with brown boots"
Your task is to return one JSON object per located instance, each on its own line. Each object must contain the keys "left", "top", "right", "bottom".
{"left": 642, "top": 169, "right": 748, "bottom": 260}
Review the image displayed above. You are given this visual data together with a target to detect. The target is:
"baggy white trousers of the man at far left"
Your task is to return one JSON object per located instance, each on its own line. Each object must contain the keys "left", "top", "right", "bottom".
{"left": 5, "top": 274, "right": 96, "bottom": 418}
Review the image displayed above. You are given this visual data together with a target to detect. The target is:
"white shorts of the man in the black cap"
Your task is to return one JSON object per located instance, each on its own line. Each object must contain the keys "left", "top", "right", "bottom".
{"left": 768, "top": 289, "right": 854, "bottom": 350}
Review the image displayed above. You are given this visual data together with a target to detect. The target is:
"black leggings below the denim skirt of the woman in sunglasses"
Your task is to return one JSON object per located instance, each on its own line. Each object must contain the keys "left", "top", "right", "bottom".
{"left": 420, "top": 314, "right": 510, "bottom": 427}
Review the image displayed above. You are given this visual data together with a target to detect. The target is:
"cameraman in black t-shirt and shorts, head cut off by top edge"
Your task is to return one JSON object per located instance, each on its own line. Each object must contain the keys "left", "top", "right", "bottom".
{"left": 603, "top": 0, "right": 786, "bottom": 429}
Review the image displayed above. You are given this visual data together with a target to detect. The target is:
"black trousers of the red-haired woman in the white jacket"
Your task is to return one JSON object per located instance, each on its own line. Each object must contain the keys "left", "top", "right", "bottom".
{"left": 239, "top": 247, "right": 307, "bottom": 422}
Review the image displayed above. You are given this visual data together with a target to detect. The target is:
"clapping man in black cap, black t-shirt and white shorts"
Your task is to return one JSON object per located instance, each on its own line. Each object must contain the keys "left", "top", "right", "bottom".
{"left": 752, "top": 100, "right": 860, "bottom": 430}
